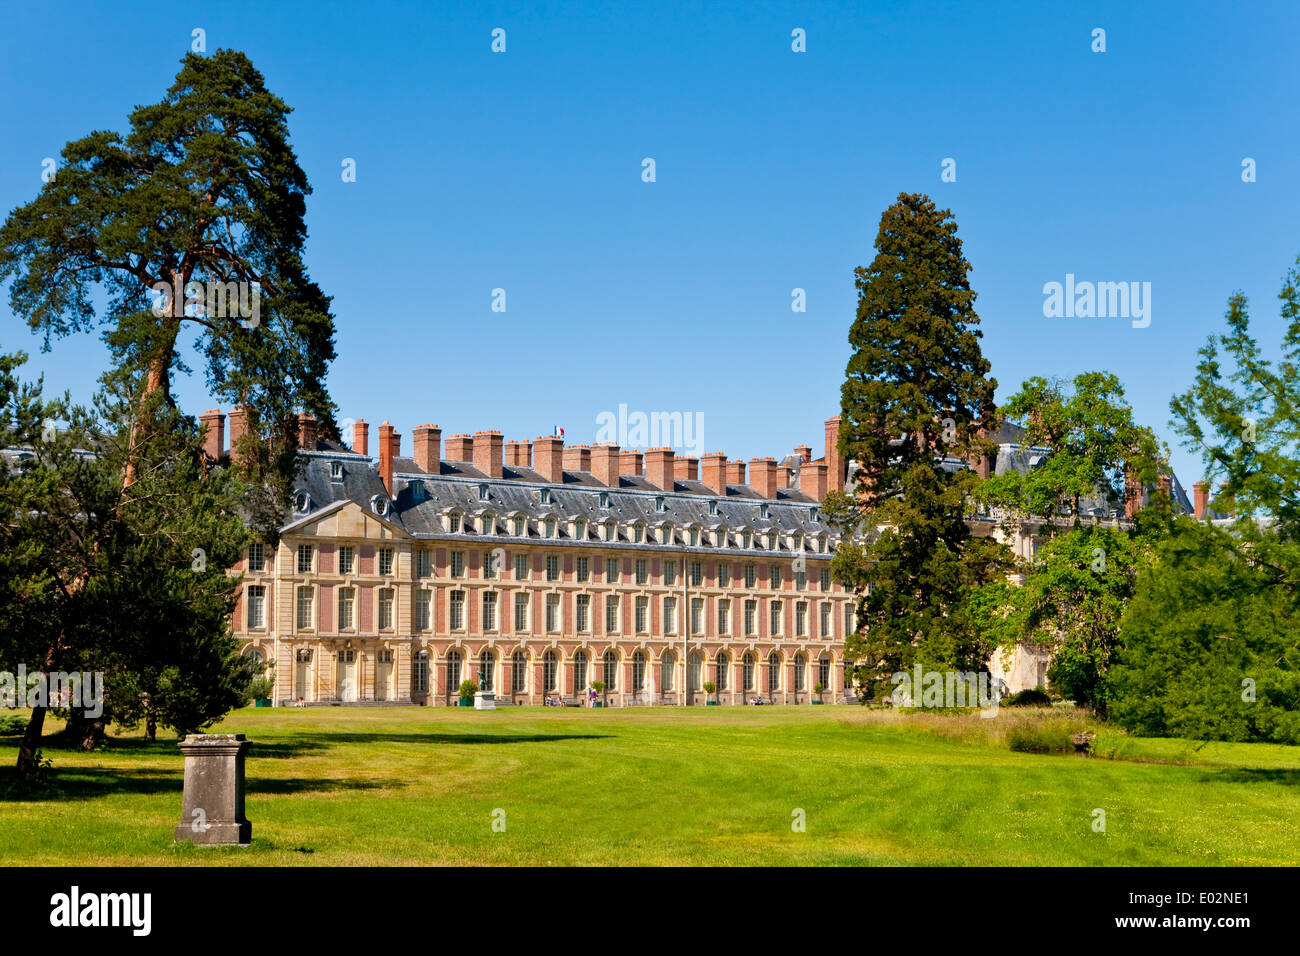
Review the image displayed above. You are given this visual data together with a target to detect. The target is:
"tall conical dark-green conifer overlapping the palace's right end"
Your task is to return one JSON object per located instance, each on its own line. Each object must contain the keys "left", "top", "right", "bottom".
{"left": 826, "top": 194, "right": 1008, "bottom": 695}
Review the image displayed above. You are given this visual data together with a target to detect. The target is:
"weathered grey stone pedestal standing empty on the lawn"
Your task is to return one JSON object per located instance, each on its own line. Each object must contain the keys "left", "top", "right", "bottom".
{"left": 176, "top": 734, "right": 252, "bottom": 847}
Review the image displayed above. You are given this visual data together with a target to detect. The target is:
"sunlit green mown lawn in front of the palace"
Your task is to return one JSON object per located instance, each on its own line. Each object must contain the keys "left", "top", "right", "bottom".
{"left": 0, "top": 706, "right": 1300, "bottom": 866}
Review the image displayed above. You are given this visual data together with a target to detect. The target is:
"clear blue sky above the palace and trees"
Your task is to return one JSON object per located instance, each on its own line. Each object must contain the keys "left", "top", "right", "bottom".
{"left": 0, "top": 3, "right": 1300, "bottom": 485}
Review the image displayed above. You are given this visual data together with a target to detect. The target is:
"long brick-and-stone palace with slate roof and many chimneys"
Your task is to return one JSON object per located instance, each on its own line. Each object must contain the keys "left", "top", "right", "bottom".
{"left": 215, "top": 408, "right": 854, "bottom": 706}
